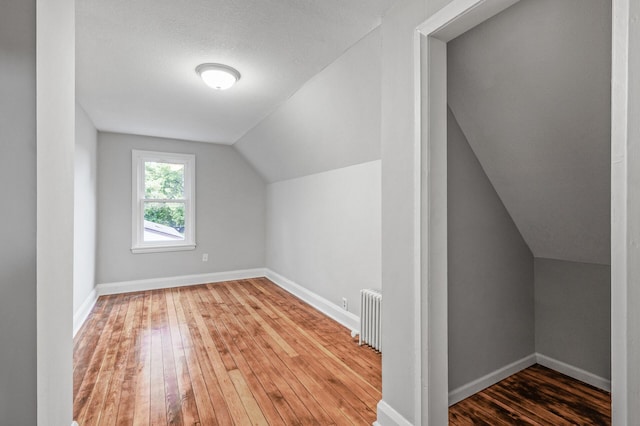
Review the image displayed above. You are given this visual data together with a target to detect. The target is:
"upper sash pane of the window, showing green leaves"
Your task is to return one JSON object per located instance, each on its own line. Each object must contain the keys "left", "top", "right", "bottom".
{"left": 144, "top": 161, "right": 185, "bottom": 200}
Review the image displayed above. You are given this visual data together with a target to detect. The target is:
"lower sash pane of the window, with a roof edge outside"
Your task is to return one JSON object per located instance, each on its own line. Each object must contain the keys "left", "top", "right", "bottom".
{"left": 144, "top": 202, "right": 185, "bottom": 241}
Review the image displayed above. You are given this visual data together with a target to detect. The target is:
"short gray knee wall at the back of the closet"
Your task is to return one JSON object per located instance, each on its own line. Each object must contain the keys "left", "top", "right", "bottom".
{"left": 534, "top": 258, "right": 611, "bottom": 379}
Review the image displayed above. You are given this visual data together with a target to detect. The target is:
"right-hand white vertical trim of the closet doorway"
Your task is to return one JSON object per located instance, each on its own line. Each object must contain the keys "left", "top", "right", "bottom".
{"left": 611, "top": 0, "right": 640, "bottom": 426}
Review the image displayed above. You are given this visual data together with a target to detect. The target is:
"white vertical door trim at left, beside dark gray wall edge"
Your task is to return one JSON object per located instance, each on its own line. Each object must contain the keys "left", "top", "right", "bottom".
{"left": 34, "top": 0, "right": 76, "bottom": 426}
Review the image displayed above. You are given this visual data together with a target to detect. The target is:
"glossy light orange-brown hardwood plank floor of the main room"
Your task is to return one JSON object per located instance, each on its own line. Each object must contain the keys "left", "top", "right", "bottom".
{"left": 73, "top": 278, "right": 381, "bottom": 426}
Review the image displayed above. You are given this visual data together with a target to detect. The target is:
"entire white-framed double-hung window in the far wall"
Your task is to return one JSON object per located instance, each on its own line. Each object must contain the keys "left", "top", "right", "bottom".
{"left": 131, "top": 150, "right": 196, "bottom": 253}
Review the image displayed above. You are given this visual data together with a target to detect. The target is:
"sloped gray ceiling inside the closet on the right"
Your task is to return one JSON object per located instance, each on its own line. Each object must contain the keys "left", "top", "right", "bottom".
{"left": 448, "top": 0, "right": 611, "bottom": 264}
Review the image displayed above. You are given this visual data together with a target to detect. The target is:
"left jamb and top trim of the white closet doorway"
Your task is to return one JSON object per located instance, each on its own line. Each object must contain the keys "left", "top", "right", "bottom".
{"left": 414, "top": 0, "right": 517, "bottom": 425}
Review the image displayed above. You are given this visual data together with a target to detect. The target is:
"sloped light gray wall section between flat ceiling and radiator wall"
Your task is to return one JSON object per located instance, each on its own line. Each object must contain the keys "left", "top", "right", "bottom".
{"left": 234, "top": 29, "right": 381, "bottom": 182}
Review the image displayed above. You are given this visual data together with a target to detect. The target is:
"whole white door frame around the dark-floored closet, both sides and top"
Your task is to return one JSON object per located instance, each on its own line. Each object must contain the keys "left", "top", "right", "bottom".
{"left": 414, "top": 0, "right": 640, "bottom": 425}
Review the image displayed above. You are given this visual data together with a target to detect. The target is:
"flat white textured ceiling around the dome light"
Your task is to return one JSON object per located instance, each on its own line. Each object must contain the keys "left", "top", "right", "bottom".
{"left": 76, "top": 0, "right": 395, "bottom": 144}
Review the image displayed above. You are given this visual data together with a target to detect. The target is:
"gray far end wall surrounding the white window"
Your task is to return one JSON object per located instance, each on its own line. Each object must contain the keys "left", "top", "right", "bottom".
{"left": 96, "top": 132, "right": 265, "bottom": 284}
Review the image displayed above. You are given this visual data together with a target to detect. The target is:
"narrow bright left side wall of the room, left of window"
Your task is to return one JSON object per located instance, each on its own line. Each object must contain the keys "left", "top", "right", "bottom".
{"left": 73, "top": 104, "right": 98, "bottom": 313}
